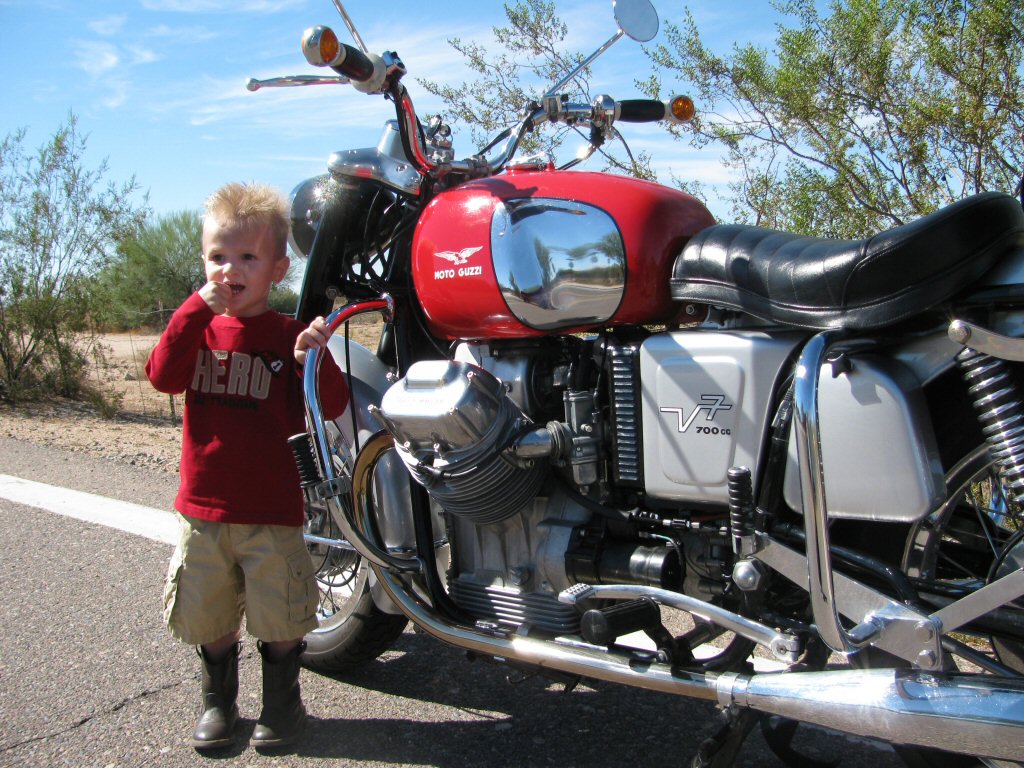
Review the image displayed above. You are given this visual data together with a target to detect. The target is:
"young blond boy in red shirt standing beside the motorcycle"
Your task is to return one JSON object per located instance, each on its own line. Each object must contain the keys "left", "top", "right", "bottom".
{"left": 145, "top": 183, "right": 348, "bottom": 750}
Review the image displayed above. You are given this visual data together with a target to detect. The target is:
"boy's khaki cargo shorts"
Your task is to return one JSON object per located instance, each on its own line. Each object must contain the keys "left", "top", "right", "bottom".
{"left": 164, "top": 514, "right": 318, "bottom": 645}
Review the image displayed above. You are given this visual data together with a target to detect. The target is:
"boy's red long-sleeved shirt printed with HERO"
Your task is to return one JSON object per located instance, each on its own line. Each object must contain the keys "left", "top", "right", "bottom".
{"left": 145, "top": 293, "right": 348, "bottom": 525}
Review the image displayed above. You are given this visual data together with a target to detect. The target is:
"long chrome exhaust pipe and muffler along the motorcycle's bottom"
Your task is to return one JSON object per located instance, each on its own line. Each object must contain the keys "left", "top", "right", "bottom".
{"left": 348, "top": 435, "right": 1024, "bottom": 761}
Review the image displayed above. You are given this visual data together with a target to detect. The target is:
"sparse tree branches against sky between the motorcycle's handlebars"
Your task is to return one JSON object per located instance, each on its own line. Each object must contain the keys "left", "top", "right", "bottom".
{"left": 420, "top": 0, "right": 654, "bottom": 178}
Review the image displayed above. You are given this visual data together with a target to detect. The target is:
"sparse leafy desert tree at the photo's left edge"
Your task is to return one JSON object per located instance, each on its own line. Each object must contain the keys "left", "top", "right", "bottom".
{"left": 0, "top": 115, "right": 143, "bottom": 399}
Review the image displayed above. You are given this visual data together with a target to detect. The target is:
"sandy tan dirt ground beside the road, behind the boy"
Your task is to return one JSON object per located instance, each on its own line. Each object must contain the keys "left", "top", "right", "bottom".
{"left": 0, "top": 323, "right": 380, "bottom": 474}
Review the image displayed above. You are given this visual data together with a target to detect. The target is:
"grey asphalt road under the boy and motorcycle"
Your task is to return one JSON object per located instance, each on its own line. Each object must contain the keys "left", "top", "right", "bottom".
{"left": 0, "top": 438, "right": 902, "bottom": 768}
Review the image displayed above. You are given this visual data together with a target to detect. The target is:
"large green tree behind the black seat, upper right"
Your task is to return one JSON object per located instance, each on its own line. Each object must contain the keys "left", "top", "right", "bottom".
{"left": 646, "top": 0, "right": 1024, "bottom": 238}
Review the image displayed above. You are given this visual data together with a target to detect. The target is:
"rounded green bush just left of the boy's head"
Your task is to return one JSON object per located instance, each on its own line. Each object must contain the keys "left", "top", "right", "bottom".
{"left": 101, "top": 211, "right": 206, "bottom": 328}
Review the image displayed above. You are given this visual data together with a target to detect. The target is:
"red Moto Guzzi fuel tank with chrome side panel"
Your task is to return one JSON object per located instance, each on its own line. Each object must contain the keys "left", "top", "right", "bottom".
{"left": 413, "top": 169, "right": 715, "bottom": 339}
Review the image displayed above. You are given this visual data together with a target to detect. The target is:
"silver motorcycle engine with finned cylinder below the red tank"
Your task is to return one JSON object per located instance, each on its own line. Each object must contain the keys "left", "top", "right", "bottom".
{"left": 373, "top": 337, "right": 708, "bottom": 634}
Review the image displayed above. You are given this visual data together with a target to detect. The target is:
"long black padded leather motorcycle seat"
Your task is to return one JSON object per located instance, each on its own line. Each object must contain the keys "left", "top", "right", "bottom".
{"left": 671, "top": 193, "right": 1024, "bottom": 330}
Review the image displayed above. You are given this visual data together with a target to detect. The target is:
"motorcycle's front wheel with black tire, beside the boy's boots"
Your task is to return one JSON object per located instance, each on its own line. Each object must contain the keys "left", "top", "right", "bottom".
{"left": 301, "top": 505, "right": 408, "bottom": 674}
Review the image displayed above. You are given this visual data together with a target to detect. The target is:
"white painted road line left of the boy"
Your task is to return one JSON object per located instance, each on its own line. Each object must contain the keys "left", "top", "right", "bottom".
{"left": 0, "top": 474, "right": 178, "bottom": 544}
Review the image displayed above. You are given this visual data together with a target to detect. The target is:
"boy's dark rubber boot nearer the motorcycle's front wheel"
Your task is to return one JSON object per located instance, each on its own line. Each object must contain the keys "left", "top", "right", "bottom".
{"left": 249, "top": 642, "right": 306, "bottom": 749}
